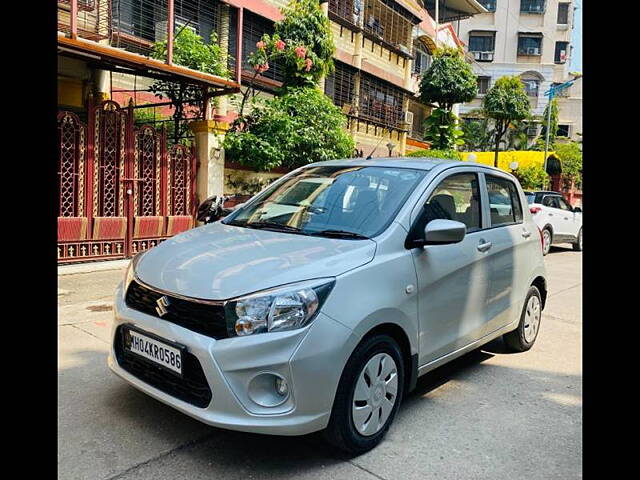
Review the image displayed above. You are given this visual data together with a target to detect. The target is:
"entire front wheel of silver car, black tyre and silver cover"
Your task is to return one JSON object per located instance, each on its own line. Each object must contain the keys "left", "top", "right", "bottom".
{"left": 324, "top": 334, "right": 405, "bottom": 454}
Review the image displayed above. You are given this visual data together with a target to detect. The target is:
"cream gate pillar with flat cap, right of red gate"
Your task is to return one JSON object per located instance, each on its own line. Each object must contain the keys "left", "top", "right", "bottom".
{"left": 189, "top": 120, "right": 229, "bottom": 204}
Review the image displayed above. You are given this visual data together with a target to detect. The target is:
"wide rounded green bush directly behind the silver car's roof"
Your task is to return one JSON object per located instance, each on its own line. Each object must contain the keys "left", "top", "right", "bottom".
{"left": 223, "top": 87, "right": 355, "bottom": 170}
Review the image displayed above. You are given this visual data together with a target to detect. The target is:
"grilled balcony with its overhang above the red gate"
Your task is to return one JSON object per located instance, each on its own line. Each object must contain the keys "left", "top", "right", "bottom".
{"left": 56, "top": 0, "right": 241, "bottom": 95}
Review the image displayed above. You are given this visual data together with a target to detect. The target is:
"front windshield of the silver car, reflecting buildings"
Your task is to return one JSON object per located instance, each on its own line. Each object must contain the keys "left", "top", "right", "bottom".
{"left": 223, "top": 166, "right": 426, "bottom": 239}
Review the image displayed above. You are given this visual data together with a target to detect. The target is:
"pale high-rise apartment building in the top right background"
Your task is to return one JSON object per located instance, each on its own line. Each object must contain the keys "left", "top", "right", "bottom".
{"left": 459, "top": 0, "right": 582, "bottom": 138}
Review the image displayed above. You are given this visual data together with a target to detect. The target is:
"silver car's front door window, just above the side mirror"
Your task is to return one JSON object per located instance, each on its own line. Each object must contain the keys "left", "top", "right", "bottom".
{"left": 419, "top": 173, "right": 480, "bottom": 232}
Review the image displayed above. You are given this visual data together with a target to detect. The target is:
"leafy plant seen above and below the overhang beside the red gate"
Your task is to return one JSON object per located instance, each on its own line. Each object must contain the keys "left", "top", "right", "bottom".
{"left": 149, "top": 28, "right": 229, "bottom": 143}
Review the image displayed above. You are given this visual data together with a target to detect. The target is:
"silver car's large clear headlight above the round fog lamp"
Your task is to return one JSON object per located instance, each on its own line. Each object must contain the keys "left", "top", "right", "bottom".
{"left": 225, "top": 278, "right": 335, "bottom": 336}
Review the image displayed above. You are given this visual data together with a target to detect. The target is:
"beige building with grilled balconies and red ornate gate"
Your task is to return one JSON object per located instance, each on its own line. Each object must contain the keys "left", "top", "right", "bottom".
{"left": 56, "top": 0, "right": 482, "bottom": 262}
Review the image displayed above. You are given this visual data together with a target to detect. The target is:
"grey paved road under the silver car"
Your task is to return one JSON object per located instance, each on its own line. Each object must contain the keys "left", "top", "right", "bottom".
{"left": 58, "top": 248, "right": 582, "bottom": 480}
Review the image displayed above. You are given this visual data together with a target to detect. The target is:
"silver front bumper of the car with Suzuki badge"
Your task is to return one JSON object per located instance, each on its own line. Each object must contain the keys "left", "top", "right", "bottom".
{"left": 108, "top": 284, "right": 357, "bottom": 435}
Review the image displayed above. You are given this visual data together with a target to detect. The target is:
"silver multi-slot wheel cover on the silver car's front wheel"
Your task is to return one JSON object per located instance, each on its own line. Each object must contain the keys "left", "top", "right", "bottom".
{"left": 351, "top": 353, "right": 398, "bottom": 436}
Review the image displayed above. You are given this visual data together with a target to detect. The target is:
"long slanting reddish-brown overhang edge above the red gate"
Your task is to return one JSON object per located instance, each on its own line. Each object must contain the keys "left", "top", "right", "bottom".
{"left": 58, "top": 34, "right": 240, "bottom": 96}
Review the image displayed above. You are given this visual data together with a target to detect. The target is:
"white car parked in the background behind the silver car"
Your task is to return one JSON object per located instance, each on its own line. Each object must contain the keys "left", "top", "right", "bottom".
{"left": 524, "top": 191, "right": 582, "bottom": 255}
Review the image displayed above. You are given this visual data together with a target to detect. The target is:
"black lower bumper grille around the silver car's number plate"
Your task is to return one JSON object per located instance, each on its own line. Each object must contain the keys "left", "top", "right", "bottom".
{"left": 113, "top": 325, "right": 211, "bottom": 408}
